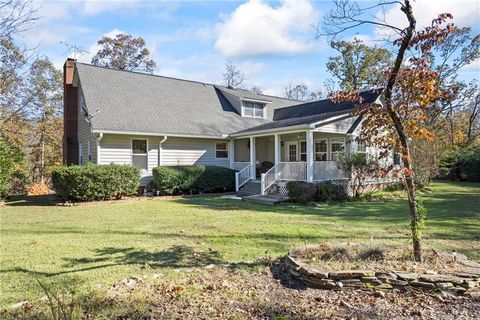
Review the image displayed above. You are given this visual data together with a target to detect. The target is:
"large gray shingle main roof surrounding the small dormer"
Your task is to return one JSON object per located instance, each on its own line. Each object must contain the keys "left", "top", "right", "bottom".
{"left": 76, "top": 63, "right": 299, "bottom": 137}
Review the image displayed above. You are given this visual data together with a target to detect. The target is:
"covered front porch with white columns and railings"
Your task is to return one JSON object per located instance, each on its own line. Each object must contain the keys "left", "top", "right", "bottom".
{"left": 230, "top": 129, "right": 365, "bottom": 194}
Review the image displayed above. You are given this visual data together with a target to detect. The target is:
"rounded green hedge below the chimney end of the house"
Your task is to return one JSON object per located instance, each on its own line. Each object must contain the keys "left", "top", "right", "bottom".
{"left": 52, "top": 163, "right": 140, "bottom": 201}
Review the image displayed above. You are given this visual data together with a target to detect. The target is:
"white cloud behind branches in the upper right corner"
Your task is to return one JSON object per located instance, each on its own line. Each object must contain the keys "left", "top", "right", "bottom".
{"left": 376, "top": 0, "right": 480, "bottom": 36}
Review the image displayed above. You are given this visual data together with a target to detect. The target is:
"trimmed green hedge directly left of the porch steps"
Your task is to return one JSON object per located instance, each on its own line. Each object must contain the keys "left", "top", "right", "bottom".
{"left": 153, "top": 166, "right": 235, "bottom": 195}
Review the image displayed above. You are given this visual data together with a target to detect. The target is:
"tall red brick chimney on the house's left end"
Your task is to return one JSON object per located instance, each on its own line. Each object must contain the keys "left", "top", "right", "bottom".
{"left": 63, "top": 58, "right": 79, "bottom": 165}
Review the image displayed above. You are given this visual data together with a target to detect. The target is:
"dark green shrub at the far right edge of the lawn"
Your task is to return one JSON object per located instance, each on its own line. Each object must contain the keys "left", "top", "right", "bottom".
{"left": 439, "top": 146, "right": 480, "bottom": 182}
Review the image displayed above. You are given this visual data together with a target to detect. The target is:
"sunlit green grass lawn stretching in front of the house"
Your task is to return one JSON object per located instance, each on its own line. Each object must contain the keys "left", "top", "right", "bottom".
{"left": 0, "top": 182, "right": 480, "bottom": 306}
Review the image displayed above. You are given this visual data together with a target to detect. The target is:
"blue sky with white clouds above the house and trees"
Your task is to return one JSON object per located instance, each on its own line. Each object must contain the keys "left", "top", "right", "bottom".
{"left": 17, "top": 0, "right": 480, "bottom": 95}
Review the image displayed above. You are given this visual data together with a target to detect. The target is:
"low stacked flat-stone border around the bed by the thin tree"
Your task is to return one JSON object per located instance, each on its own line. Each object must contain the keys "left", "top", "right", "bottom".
{"left": 284, "top": 255, "right": 480, "bottom": 294}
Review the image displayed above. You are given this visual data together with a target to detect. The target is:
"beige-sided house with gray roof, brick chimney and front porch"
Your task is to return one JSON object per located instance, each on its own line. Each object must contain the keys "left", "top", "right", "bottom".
{"left": 64, "top": 59, "right": 381, "bottom": 194}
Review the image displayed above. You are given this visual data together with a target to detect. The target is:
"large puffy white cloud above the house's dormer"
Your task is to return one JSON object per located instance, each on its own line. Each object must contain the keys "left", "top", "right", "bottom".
{"left": 215, "top": 0, "right": 318, "bottom": 56}
